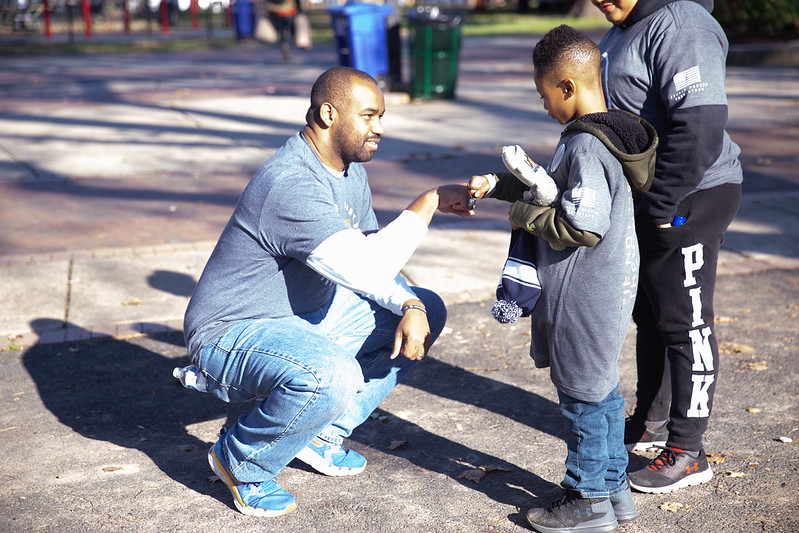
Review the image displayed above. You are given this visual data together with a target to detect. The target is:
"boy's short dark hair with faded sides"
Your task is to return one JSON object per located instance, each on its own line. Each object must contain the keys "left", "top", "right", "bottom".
{"left": 533, "top": 24, "right": 601, "bottom": 85}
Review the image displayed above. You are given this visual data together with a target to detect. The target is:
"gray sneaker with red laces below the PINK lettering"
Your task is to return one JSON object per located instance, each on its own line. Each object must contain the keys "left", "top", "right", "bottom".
{"left": 627, "top": 448, "right": 713, "bottom": 494}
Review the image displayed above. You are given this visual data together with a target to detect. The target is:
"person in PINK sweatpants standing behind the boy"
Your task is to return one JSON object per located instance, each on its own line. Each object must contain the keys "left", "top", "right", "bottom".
{"left": 592, "top": 0, "right": 743, "bottom": 493}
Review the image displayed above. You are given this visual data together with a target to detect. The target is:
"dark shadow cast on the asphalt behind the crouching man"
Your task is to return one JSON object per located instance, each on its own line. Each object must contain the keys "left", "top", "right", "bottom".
{"left": 23, "top": 319, "right": 241, "bottom": 504}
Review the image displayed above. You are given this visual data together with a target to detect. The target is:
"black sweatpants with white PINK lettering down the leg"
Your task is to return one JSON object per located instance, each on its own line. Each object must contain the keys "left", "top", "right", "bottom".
{"left": 633, "top": 184, "right": 741, "bottom": 451}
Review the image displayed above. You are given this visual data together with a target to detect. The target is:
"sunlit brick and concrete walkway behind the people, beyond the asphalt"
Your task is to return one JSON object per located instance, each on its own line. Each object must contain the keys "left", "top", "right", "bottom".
{"left": 0, "top": 33, "right": 799, "bottom": 348}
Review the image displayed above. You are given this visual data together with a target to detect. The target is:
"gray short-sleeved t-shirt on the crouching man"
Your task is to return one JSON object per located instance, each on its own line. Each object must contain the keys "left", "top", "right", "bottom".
{"left": 184, "top": 133, "right": 378, "bottom": 358}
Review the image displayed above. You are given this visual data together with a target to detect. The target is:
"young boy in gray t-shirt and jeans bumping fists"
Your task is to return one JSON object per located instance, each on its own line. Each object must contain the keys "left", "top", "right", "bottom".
{"left": 470, "top": 26, "right": 657, "bottom": 533}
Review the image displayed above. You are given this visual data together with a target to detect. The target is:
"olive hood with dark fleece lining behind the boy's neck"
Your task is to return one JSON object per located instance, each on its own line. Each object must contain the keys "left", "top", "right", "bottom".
{"left": 561, "top": 109, "right": 658, "bottom": 191}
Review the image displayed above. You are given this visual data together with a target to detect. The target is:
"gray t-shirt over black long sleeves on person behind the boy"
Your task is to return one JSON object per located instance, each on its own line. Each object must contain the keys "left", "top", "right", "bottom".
{"left": 599, "top": 0, "right": 743, "bottom": 225}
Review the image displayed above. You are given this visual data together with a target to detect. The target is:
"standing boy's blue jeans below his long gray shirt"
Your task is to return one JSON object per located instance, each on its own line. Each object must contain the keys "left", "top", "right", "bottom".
{"left": 558, "top": 385, "right": 628, "bottom": 498}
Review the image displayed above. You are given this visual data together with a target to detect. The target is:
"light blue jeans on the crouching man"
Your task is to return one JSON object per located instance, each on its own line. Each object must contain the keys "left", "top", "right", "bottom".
{"left": 197, "top": 286, "right": 446, "bottom": 483}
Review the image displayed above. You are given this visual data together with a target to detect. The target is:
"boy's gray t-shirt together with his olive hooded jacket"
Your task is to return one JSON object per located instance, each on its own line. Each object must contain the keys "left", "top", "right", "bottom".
{"left": 490, "top": 111, "right": 657, "bottom": 402}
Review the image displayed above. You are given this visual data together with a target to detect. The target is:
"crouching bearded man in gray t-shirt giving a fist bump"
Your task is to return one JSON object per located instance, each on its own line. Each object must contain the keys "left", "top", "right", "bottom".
{"left": 185, "top": 67, "right": 473, "bottom": 516}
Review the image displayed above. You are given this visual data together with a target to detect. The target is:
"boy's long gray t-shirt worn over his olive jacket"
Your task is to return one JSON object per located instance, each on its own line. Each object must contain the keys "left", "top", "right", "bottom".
{"left": 530, "top": 132, "right": 639, "bottom": 402}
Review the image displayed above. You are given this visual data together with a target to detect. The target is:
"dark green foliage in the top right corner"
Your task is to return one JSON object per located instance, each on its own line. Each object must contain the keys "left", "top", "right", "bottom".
{"left": 713, "top": 0, "right": 799, "bottom": 41}
